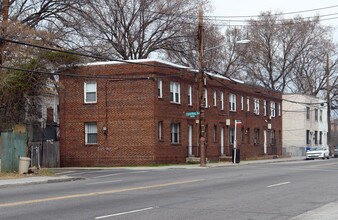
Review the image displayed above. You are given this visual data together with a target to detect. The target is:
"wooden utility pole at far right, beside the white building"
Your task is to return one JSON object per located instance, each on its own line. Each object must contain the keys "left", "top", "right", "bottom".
{"left": 325, "top": 54, "right": 333, "bottom": 152}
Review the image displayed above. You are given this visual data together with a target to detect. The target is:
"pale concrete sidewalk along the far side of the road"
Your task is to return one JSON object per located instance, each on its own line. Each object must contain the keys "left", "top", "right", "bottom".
{"left": 0, "top": 157, "right": 304, "bottom": 188}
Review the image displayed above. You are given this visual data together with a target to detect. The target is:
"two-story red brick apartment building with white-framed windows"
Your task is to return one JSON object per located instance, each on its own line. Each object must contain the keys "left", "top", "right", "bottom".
{"left": 60, "top": 60, "right": 282, "bottom": 166}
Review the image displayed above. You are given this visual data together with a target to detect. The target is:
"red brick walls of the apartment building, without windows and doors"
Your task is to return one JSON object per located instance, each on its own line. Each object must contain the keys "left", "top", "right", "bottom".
{"left": 60, "top": 63, "right": 282, "bottom": 166}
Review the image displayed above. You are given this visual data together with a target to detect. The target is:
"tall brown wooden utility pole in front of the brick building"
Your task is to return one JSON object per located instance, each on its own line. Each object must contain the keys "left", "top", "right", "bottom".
{"left": 198, "top": 6, "right": 206, "bottom": 167}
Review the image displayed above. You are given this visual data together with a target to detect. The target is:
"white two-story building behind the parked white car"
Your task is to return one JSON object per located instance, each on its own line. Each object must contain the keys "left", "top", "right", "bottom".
{"left": 282, "top": 94, "right": 328, "bottom": 156}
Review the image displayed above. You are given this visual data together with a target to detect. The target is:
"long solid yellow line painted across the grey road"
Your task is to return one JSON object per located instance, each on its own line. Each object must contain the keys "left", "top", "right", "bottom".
{"left": 0, "top": 179, "right": 205, "bottom": 207}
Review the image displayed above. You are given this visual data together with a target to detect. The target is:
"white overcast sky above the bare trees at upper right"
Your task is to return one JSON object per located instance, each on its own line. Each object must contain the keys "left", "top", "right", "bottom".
{"left": 206, "top": 0, "right": 338, "bottom": 41}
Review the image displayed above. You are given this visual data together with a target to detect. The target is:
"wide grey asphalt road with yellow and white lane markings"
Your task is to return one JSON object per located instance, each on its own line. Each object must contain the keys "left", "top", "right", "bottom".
{"left": 0, "top": 159, "right": 338, "bottom": 220}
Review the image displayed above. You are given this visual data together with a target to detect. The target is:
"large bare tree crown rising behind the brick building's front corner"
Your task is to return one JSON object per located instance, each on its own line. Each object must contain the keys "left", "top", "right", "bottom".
{"left": 60, "top": 0, "right": 206, "bottom": 59}
